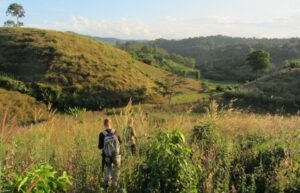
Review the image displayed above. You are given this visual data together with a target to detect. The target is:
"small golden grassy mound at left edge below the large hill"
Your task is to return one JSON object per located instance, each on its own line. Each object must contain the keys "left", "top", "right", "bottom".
{"left": 0, "top": 89, "right": 48, "bottom": 124}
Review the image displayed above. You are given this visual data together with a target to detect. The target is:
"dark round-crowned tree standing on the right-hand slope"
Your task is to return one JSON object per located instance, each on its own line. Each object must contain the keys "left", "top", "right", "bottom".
{"left": 246, "top": 50, "right": 271, "bottom": 80}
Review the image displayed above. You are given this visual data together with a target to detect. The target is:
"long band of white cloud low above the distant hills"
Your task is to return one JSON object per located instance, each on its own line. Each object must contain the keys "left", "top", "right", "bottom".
{"left": 31, "top": 11, "right": 300, "bottom": 39}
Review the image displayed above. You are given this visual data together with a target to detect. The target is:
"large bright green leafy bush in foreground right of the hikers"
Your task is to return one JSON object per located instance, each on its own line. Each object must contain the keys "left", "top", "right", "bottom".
{"left": 136, "top": 131, "right": 197, "bottom": 193}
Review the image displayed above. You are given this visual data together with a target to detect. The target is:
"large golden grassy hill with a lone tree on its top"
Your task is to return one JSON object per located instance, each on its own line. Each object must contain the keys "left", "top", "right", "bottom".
{"left": 0, "top": 28, "right": 199, "bottom": 109}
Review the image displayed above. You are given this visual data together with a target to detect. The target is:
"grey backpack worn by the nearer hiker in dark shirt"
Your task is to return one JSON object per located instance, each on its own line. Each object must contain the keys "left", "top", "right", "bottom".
{"left": 103, "top": 130, "right": 120, "bottom": 157}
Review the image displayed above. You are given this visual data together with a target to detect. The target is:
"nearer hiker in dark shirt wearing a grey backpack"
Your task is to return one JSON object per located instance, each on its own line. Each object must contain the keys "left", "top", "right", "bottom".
{"left": 98, "top": 119, "right": 122, "bottom": 188}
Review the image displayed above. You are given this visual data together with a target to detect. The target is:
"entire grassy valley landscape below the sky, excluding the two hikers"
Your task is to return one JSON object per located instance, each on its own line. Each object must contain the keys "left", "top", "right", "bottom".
{"left": 0, "top": 19, "right": 300, "bottom": 193}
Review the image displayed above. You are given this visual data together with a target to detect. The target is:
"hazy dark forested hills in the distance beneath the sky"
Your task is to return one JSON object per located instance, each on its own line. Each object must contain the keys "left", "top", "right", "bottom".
{"left": 152, "top": 36, "right": 300, "bottom": 82}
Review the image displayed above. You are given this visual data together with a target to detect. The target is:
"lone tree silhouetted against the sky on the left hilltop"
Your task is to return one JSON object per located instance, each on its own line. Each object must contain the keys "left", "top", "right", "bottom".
{"left": 4, "top": 3, "right": 25, "bottom": 27}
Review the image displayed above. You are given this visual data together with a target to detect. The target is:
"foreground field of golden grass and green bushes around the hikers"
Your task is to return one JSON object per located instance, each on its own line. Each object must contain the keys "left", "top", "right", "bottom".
{"left": 0, "top": 105, "right": 300, "bottom": 193}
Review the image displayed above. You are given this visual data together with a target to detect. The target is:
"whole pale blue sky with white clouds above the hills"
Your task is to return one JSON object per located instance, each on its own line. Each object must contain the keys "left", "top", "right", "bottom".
{"left": 0, "top": 0, "right": 300, "bottom": 40}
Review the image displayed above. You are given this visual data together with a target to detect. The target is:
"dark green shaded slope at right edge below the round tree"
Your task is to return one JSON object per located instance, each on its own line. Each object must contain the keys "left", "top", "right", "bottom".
{"left": 225, "top": 68, "right": 300, "bottom": 113}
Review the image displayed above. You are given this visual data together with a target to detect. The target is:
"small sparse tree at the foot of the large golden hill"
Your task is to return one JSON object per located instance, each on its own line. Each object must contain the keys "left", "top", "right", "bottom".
{"left": 155, "top": 76, "right": 185, "bottom": 104}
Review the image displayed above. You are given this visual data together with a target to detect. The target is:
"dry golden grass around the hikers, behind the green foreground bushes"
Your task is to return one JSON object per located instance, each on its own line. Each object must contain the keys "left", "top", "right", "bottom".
{"left": 0, "top": 102, "right": 300, "bottom": 192}
